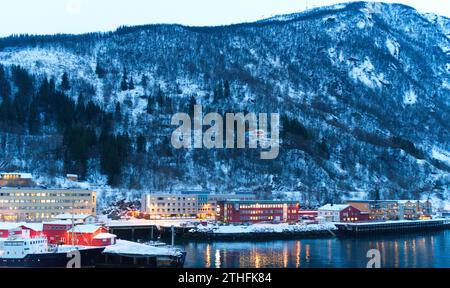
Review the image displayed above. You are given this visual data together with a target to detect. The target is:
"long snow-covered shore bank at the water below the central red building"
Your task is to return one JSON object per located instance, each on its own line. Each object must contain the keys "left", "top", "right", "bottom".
{"left": 189, "top": 223, "right": 337, "bottom": 234}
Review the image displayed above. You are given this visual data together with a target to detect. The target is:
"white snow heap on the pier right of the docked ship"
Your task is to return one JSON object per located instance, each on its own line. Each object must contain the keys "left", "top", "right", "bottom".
{"left": 103, "top": 240, "right": 182, "bottom": 256}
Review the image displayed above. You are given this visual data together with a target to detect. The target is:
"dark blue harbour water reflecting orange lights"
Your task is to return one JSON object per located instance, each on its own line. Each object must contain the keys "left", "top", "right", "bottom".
{"left": 179, "top": 231, "right": 450, "bottom": 268}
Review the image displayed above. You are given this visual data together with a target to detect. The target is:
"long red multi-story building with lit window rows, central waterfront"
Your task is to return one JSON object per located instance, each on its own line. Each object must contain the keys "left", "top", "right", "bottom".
{"left": 217, "top": 200, "right": 300, "bottom": 224}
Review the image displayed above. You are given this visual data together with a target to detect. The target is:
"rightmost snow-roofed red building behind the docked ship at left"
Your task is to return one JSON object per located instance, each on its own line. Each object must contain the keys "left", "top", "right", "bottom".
{"left": 66, "top": 225, "right": 116, "bottom": 247}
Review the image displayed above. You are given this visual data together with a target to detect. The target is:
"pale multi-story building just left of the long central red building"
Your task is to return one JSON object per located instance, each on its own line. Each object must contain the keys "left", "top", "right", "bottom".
{"left": 141, "top": 191, "right": 256, "bottom": 219}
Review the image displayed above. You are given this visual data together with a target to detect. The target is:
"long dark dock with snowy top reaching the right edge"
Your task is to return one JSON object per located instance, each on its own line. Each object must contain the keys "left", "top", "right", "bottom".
{"left": 335, "top": 219, "right": 450, "bottom": 236}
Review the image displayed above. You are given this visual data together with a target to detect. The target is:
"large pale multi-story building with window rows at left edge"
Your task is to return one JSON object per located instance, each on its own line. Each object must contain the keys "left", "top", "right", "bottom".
{"left": 0, "top": 188, "right": 97, "bottom": 222}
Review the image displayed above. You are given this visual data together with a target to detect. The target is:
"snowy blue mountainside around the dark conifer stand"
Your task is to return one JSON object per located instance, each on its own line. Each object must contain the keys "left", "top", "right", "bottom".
{"left": 0, "top": 2, "right": 450, "bottom": 205}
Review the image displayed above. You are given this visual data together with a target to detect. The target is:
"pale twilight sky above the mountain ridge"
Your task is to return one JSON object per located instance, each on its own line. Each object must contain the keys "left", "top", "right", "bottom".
{"left": 0, "top": 0, "right": 450, "bottom": 36}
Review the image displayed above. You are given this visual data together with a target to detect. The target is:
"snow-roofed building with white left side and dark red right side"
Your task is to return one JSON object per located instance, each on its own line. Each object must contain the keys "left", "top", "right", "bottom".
{"left": 318, "top": 204, "right": 369, "bottom": 222}
